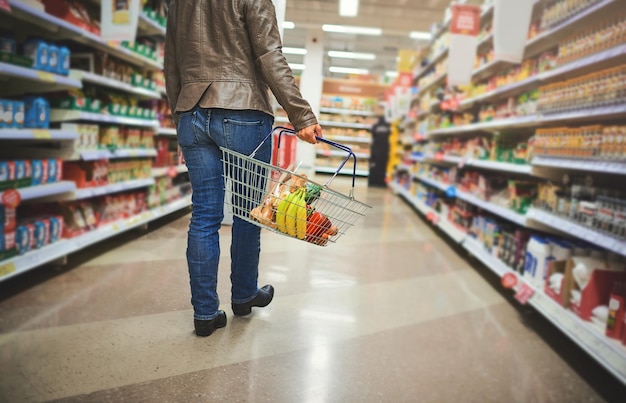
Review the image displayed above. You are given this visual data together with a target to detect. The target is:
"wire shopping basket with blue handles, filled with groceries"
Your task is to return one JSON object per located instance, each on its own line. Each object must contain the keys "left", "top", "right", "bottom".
{"left": 220, "top": 126, "right": 371, "bottom": 246}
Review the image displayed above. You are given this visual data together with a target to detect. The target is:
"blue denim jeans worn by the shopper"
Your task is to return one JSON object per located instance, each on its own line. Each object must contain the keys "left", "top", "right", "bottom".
{"left": 178, "top": 107, "right": 274, "bottom": 320}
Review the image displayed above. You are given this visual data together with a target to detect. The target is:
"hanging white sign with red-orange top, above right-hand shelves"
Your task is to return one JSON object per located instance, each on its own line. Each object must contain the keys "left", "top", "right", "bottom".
{"left": 448, "top": 4, "right": 480, "bottom": 86}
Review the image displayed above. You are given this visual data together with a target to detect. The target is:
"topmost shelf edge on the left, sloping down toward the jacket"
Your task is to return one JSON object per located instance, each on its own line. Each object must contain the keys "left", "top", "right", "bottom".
{"left": 9, "top": 0, "right": 163, "bottom": 70}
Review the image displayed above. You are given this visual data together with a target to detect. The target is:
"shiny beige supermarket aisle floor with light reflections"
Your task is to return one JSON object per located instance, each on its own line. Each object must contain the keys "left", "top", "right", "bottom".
{"left": 0, "top": 180, "right": 626, "bottom": 402}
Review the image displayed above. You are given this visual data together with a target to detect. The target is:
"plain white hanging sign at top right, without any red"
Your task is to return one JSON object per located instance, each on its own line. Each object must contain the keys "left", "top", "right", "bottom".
{"left": 493, "top": 0, "right": 535, "bottom": 63}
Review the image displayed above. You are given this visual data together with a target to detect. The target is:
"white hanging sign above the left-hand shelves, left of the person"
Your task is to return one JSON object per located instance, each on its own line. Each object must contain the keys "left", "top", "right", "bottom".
{"left": 100, "top": 0, "right": 140, "bottom": 42}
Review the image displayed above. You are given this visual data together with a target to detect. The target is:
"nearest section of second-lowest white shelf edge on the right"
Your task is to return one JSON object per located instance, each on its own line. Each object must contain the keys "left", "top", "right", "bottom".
{"left": 526, "top": 208, "right": 626, "bottom": 256}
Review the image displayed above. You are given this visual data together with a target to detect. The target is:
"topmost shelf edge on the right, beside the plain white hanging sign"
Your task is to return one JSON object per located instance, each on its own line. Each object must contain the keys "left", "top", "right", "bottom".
{"left": 524, "top": 0, "right": 622, "bottom": 58}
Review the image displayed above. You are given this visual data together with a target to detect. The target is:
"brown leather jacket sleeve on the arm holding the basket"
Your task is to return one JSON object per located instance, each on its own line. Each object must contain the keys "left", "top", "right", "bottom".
{"left": 244, "top": 0, "right": 317, "bottom": 130}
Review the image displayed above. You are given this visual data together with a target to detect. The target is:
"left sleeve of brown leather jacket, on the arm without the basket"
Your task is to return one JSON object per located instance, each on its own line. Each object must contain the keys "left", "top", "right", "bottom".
{"left": 163, "top": 1, "right": 181, "bottom": 125}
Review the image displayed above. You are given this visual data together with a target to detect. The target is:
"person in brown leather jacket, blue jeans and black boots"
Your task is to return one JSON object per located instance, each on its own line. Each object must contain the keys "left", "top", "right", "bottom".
{"left": 165, "top": 0, "right": 322, "bottom": 337}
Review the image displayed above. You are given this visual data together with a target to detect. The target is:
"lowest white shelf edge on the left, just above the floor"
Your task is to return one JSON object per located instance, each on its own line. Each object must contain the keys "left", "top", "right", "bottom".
{"left": 0, "top": 196, "right": 191, "bottom": 281}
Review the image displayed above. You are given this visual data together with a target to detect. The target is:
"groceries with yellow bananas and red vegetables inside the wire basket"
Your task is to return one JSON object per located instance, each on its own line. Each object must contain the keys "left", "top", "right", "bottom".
{"left": 250, "top": 172, "right": 339, "bottom": 246}
